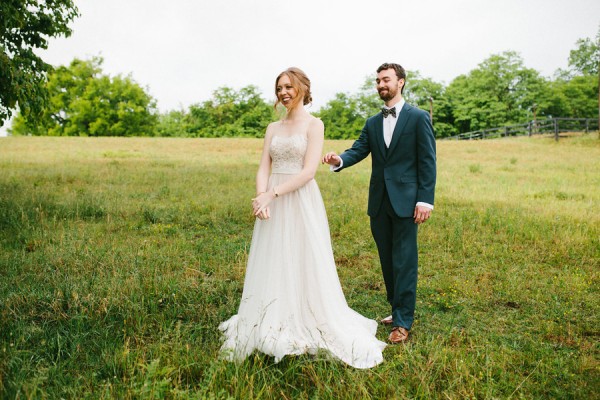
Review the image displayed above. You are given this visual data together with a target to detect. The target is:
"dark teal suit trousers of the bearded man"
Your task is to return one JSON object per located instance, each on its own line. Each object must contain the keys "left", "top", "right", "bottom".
{"left": 371, "top": 191, "right": 419, "bottom": 330}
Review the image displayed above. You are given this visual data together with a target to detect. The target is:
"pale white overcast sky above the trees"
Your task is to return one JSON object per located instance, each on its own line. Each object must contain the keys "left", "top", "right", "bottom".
{"left": 0, "top": 0, "right": 600, "bottom": 134}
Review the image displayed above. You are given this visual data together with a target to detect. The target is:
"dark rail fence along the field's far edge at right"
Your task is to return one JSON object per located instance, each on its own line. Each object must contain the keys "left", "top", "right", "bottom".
{"left": 444, "top": 118, "right": 598, "bottom": 140}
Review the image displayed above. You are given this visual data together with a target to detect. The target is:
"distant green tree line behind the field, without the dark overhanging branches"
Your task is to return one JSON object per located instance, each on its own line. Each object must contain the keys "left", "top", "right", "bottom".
{"left": 8, "top": 27, "right": 600, "bottom": 139}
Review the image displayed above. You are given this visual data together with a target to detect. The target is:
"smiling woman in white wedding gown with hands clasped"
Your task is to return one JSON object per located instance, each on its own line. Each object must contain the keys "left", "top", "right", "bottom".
{"left": 219, "top": 68, "right": 385, "bottom": 368}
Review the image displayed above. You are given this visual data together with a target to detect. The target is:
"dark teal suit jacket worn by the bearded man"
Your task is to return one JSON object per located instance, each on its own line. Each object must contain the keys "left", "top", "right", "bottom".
{"left": 337, "top": 103, "right": 436, "bottom": 218}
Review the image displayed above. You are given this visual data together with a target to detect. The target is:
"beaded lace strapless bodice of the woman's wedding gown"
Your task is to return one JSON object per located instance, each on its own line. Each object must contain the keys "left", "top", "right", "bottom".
{"left": 269, "top": 135, "right": 308, "bottom": 174}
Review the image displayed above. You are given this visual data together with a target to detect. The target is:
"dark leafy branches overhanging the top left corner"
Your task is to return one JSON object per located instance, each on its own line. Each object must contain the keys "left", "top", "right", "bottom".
{"left": 0, "top": 0, "right": 79, "bottom": 126}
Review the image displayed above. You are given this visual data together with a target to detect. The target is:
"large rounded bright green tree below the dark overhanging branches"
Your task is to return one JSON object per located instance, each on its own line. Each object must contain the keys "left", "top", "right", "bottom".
{"left": 11, "top": 58, "right": 157, "bottom": 136}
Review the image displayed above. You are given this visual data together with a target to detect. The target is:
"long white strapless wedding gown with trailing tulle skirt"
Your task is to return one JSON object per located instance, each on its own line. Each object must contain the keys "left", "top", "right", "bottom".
{"left": 219, "top": 135, "right": 385, "bottom": 368}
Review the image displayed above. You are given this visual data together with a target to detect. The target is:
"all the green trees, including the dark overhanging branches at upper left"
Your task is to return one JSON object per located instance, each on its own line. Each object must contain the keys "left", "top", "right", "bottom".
{"left": 0, "top": 0, "right": 600, "bottom": 139}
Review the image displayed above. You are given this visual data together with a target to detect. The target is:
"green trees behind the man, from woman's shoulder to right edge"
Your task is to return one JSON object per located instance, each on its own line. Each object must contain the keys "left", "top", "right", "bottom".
{"left": 317, "top": 31, "right": 600, "bottom": 139}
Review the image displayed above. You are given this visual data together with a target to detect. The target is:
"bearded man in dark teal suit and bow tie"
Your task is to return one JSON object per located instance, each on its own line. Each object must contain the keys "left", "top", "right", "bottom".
{"left": 323, "top": 63, "right": 436, "bottom": 343}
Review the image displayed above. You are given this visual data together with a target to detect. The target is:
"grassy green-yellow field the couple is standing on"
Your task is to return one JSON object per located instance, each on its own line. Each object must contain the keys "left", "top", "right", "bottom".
{"left": 0, "top": 135, "right": 600, "bottom": 399}
